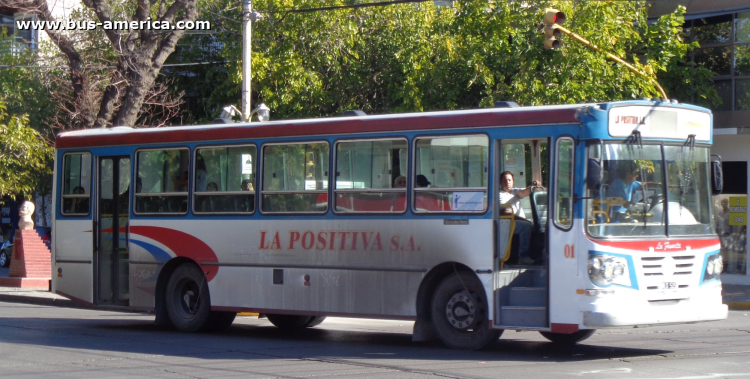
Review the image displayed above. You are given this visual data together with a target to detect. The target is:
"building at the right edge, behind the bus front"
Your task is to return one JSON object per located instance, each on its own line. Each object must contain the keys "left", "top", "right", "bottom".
{"left": 649, "top": 0, "right": 750, "bottom": 284}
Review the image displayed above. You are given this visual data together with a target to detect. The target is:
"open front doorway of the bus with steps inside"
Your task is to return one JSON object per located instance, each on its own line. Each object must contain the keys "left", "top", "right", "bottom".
{"left": 493, "top": 138, "right": 550, "bottom": 329}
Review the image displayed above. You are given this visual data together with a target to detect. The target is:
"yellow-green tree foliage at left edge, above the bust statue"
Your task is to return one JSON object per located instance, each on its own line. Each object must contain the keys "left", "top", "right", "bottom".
{"left": 0, "top": 99, "right": 53, "bottom": 195}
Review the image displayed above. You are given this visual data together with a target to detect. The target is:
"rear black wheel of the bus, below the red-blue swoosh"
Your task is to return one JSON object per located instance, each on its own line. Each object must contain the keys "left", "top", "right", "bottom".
{"left": 165, "top": 264, "right": 211, "bottom": 332}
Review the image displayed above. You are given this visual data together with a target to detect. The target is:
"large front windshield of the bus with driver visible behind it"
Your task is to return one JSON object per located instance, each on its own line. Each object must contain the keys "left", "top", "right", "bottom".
{"left": 586, "top": 143, "right": 714, "bottom": 237}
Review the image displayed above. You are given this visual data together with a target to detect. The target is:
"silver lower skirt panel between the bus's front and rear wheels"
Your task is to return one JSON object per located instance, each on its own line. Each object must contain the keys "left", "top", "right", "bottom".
{"left": 210, "top": 267, "right": 424, "bottom": 318}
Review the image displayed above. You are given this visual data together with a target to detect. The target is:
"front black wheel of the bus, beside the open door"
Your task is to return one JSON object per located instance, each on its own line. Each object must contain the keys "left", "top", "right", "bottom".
{"left": 431, "top": 272, "right": 503, "bottom": 350}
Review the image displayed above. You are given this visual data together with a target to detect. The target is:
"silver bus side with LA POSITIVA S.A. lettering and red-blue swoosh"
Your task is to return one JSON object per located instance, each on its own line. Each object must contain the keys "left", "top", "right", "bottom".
{"left": 130, "top": 216, "right": 493, "bottom": 318}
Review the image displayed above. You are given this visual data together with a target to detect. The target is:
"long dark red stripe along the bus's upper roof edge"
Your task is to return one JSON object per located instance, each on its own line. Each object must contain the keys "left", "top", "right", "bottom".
{"left": 55, "top": 108, "right": 577, "bottom": 148}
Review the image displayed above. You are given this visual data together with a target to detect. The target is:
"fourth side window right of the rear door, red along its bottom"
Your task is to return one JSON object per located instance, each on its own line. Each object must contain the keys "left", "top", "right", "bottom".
{"left": 334, "top": 139, "right": 407, "bottom": 213}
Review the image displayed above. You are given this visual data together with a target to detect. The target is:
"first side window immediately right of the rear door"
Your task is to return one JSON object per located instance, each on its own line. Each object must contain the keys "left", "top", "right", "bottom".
{"left": 135, "top": 148, "right": 190, "bottom": 214}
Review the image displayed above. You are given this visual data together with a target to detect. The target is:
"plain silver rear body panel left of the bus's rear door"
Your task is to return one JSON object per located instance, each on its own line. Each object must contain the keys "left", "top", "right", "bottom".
{"left": 52, "top": 219, "right": 94, "bottom": 304}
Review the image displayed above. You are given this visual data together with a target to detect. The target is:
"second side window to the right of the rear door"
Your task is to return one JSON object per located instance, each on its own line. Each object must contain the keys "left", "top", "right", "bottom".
{"left": 193, "top": 145, "right": 257, "bottom": 214}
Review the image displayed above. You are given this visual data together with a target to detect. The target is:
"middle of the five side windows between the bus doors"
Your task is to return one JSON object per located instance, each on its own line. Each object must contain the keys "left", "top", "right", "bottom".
{"left": 261, "top": 141, "right": 329, "bottom": 213}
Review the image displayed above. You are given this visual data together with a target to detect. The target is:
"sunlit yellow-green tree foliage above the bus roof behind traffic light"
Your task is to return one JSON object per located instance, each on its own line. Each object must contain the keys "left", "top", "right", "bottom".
{"left": 175, "top": 0, "right": 718, "bottom": 118}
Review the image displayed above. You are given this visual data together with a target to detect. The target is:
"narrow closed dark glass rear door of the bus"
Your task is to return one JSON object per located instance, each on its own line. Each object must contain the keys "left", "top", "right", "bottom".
{"left": 94, "top": 156, "right": 130, "bottom": 306}
